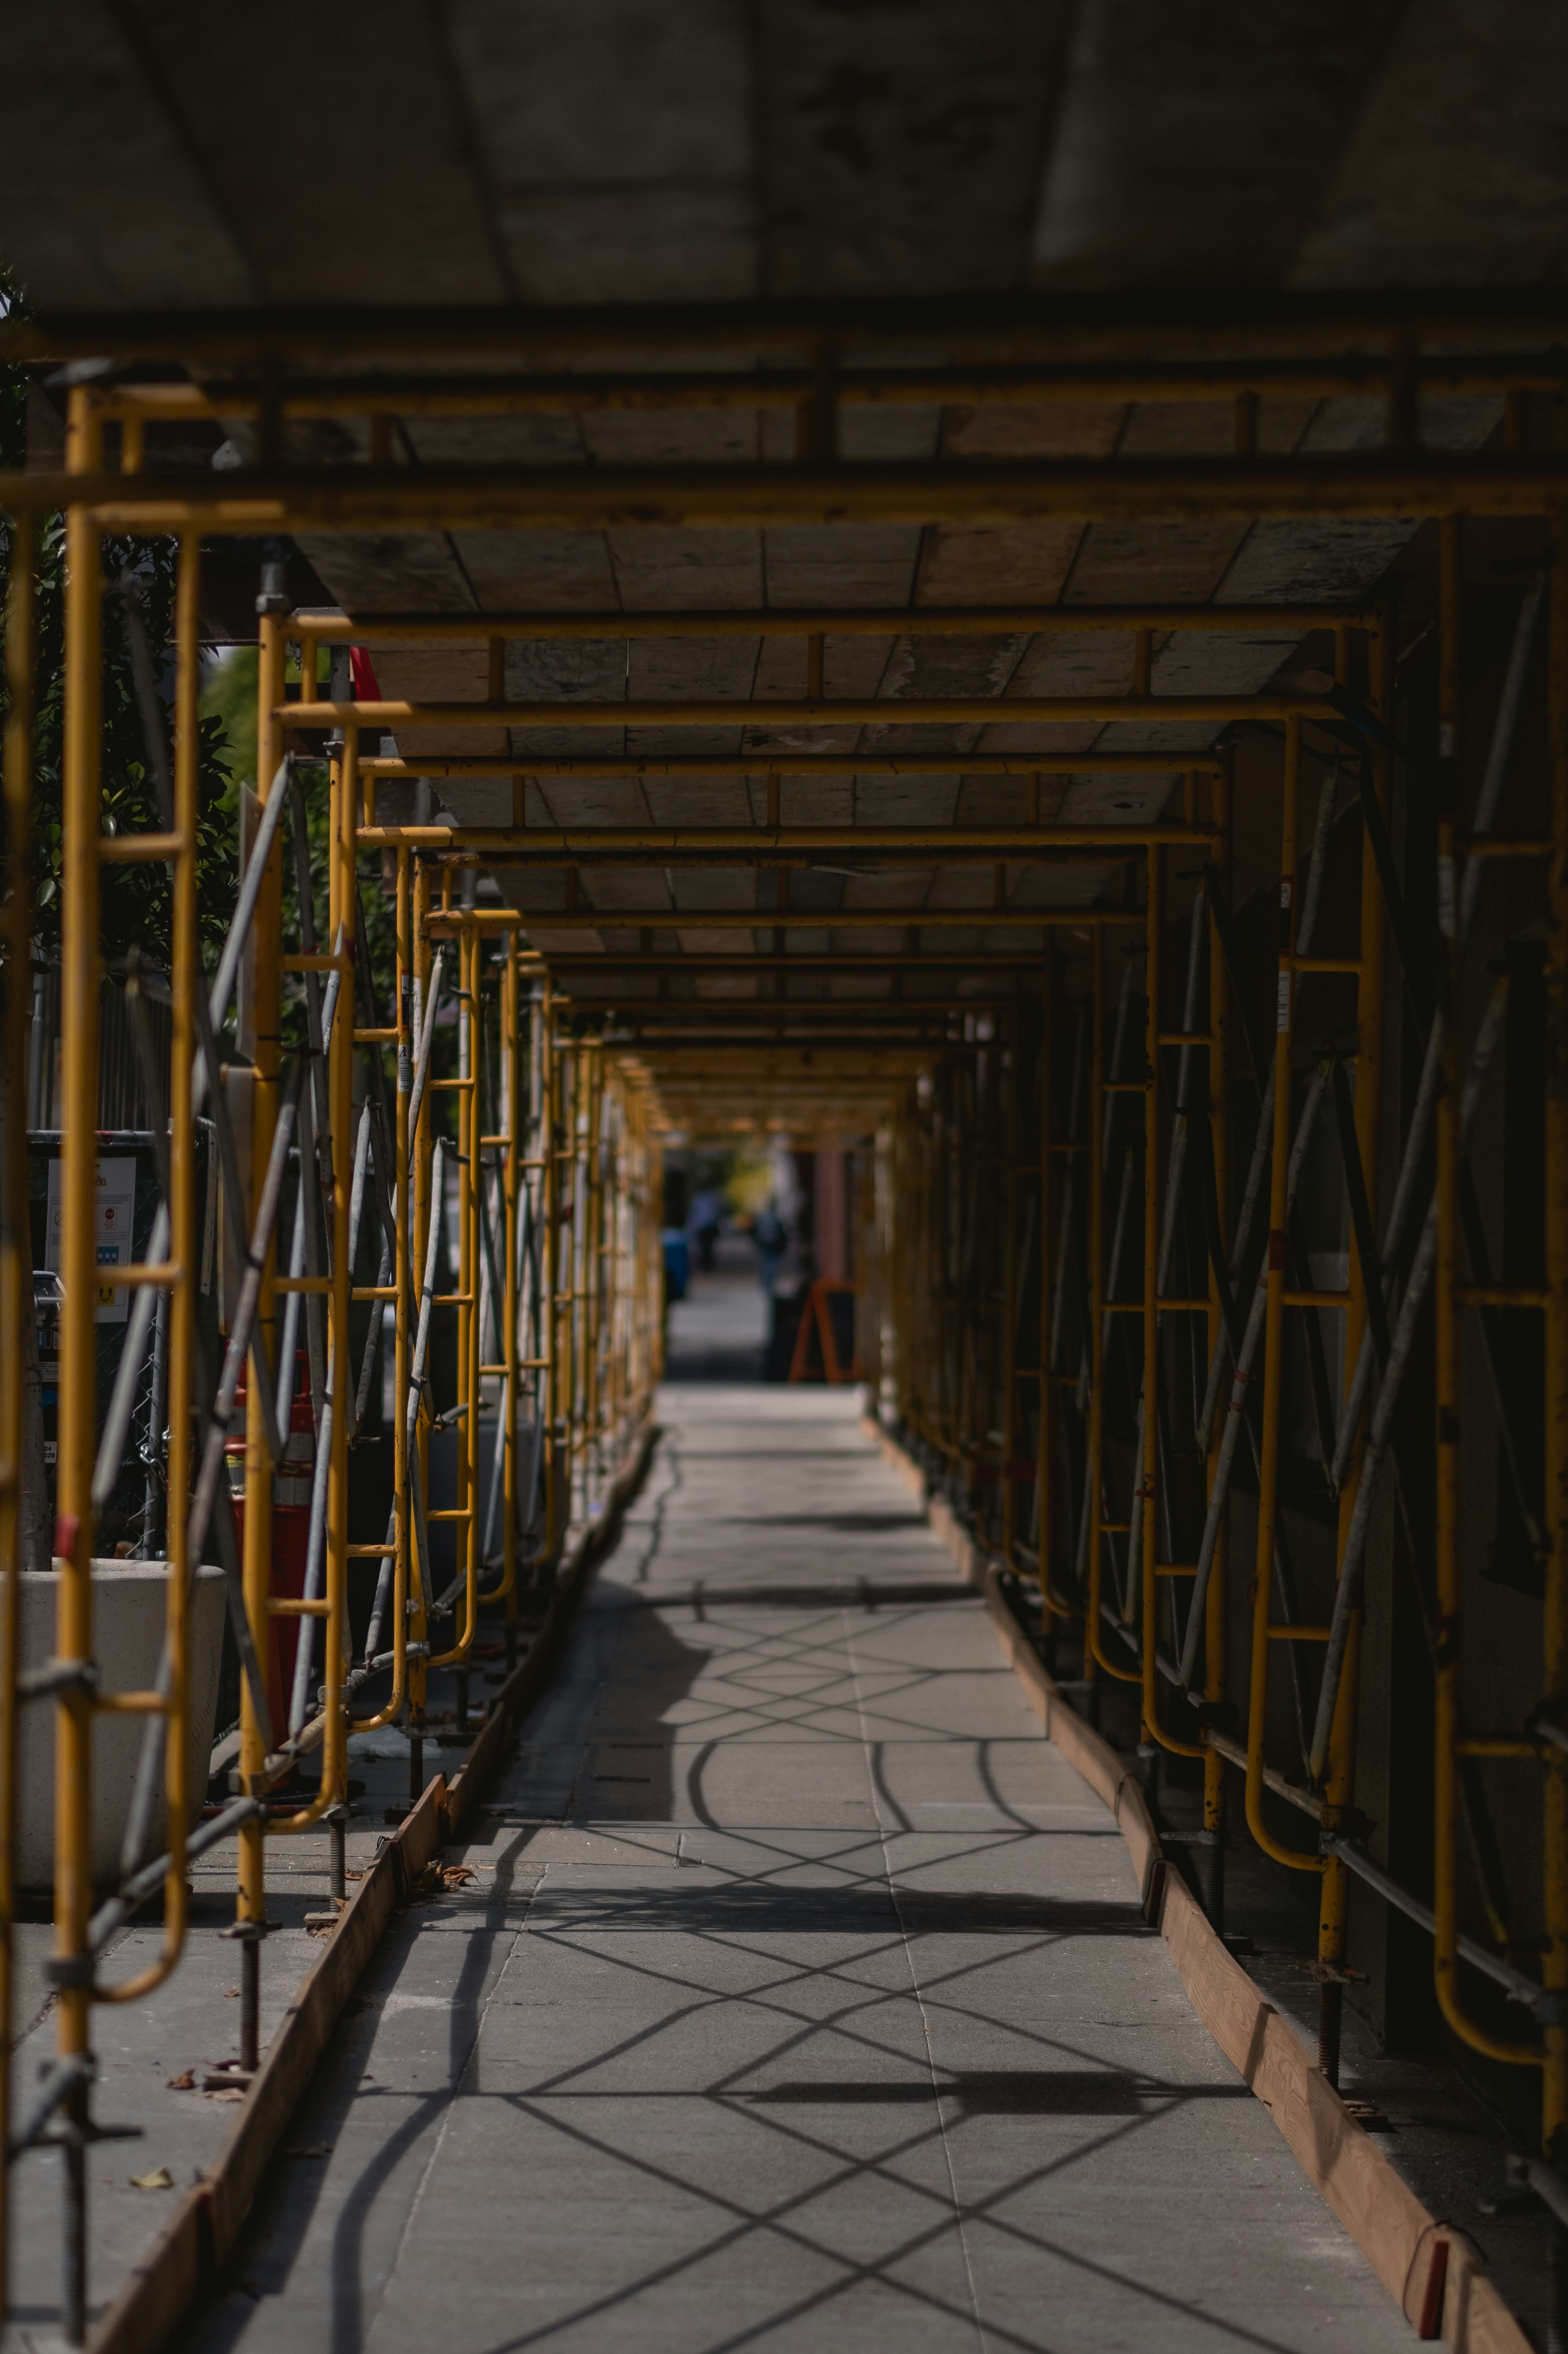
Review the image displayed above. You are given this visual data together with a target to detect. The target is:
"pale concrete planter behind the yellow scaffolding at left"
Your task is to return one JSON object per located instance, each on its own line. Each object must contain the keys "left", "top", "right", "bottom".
{"left": 16, "top": 1560, "right": 223, "bottom": 1888}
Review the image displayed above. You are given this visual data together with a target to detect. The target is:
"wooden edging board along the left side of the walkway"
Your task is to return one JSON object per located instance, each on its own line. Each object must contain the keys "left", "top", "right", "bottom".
{"left": 90, "top": 1417, "right": 659, "bottom": 2354}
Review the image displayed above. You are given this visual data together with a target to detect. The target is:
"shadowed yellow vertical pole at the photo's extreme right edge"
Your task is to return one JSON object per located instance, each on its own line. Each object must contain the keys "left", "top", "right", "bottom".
{"left": 1542, "top": 506, "right": 1568, "bottom": 2166}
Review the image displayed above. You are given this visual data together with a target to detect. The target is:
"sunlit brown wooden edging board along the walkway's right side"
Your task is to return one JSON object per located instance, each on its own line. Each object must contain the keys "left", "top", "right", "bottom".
{"left": 860, "top": 1415, "right": 1530, "bottom": 2354}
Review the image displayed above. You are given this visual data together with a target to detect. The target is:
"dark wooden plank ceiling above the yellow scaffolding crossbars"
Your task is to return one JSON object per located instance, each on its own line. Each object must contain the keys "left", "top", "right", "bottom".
{"left": 0, "top": 0, "right": 1568, "bottom": 1130}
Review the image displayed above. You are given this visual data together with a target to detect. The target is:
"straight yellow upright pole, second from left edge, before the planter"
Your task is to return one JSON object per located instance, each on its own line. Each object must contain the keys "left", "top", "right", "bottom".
{"left": 54, "top": 386, "right": 104, "bottom": 2165}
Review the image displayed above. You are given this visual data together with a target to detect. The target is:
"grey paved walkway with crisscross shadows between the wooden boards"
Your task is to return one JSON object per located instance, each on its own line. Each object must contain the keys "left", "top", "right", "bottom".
{"left": 184, "top": 1365, "right": 1410, "bottom": 2354}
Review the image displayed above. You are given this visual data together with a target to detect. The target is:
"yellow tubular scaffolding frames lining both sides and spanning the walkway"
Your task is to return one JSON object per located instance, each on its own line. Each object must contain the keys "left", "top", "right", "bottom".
{"left": 0, "top": 320, "right": 1568, "bottom": 2338}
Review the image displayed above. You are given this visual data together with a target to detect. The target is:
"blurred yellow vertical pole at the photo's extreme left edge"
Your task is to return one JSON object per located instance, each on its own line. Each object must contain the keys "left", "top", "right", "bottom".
{"left": 0, "top": 501, "right": 38, "bottom": 2314}
